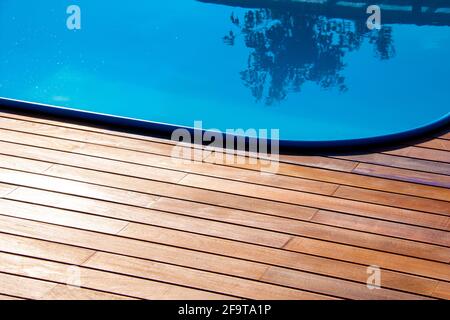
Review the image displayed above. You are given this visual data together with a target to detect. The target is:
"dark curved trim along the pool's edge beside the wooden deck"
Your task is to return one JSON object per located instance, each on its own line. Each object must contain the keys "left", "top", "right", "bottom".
{"left": 0, "top": 97, "right": 450, "bottom": 154}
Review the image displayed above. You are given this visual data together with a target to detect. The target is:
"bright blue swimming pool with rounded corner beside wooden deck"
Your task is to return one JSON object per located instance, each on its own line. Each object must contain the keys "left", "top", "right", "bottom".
{"left": 0, "top": 0, "right": 450, "bottom": 146}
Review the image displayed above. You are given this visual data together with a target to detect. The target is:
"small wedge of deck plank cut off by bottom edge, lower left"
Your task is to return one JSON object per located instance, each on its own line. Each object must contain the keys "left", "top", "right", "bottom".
{"left": 41, "top": 284, "right": 137, "bottom": 301}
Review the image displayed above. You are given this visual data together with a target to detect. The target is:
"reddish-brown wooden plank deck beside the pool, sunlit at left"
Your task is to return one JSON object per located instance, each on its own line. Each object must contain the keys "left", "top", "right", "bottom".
{"left": 0, "top": 112, "right": 450, "bottom": 299}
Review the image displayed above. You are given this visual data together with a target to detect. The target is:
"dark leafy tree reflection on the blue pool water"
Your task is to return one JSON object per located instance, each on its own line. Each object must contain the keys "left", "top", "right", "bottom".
{"left": 224, "top": 9, "right": 395, "bottom": 105}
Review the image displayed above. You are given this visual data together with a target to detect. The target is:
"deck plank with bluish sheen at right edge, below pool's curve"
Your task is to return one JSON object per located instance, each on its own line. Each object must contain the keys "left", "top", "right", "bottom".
{"left": 353, "top": 163, "right": 450, "bottom": 189}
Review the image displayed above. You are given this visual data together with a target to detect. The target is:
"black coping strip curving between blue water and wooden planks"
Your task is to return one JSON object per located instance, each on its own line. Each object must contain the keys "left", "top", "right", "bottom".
{"left": 0, "top": 97, "right": 450, "bottom": 155}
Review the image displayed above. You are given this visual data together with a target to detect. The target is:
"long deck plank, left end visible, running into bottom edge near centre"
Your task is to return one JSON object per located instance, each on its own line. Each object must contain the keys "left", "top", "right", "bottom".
{"left": 84, "top": 253, "right": 331, "bottom": 300}
